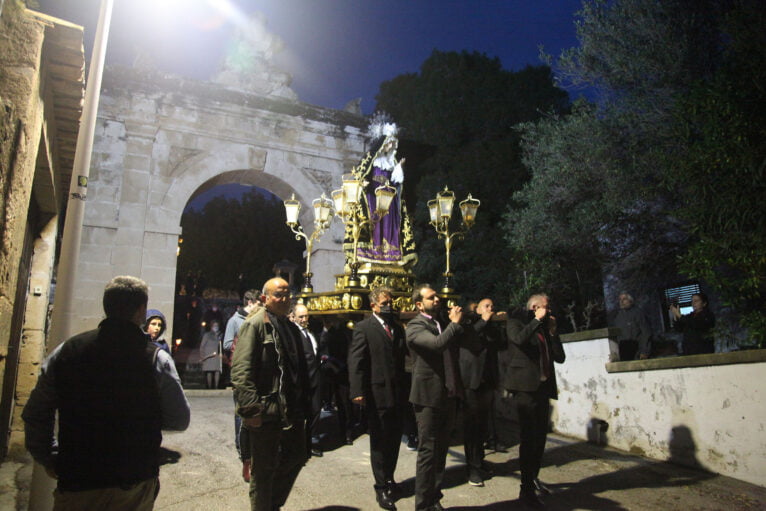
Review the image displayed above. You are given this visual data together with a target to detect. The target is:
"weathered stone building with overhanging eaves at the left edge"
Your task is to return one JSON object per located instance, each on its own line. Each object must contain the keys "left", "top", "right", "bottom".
{"left": 0, "top": 1, "right": 84, "bottom": 457}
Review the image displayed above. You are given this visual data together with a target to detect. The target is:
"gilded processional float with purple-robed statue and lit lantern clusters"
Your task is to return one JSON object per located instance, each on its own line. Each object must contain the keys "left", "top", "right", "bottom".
{"left": 284, "top": 123, "right": 480, "bottom": 318}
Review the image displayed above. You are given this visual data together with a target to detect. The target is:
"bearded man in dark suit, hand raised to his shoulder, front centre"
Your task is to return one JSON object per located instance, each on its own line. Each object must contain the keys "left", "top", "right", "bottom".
{"left": 407, "top": 284, "right": 478, "bottom": 511}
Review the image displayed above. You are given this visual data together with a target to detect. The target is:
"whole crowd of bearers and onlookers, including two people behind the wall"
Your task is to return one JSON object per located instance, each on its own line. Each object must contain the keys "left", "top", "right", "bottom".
{"left": 22, "top": 276, "right": 714, "bottom": 511}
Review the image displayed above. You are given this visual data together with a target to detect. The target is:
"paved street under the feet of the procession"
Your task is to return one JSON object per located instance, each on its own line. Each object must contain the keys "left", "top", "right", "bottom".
{"left": 155, "top": 391, "right": 766, "bottom": 511}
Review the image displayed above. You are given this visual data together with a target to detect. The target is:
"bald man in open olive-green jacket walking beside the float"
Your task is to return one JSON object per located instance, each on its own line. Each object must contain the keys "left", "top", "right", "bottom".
{"left": 231, "top": 278, "right": 311, "bottom": 511}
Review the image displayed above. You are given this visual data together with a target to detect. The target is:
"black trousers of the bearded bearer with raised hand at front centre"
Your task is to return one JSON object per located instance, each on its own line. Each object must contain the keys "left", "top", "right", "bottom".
{"left": 415, "top": 398, "right": 458, "bottom": 510}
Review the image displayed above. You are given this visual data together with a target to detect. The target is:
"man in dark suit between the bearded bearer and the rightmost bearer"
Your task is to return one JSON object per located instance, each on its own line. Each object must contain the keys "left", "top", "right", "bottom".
{"left": 460, "top": 298, "right": 505, "bottom": 486}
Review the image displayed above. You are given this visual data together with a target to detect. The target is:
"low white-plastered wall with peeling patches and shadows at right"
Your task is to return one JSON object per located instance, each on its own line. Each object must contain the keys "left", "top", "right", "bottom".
{"left": 552, "top": 329, "right": 766, "bottom": 486}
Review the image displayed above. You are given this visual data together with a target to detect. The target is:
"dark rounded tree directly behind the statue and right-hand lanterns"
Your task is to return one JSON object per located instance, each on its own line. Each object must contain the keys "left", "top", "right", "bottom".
{"left": 376, "top": 51, "right": 569, "bottom": 304}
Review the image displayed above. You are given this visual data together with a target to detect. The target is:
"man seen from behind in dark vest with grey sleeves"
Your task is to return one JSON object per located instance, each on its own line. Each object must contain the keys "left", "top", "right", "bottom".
{"left": 22, "top": 276, "right": 190, "bottom": 511}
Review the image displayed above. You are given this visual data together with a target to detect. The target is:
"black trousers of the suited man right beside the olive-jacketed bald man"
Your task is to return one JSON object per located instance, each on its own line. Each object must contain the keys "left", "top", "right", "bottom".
{"left": 366, "top": 407, "right": 402, "bottom": 489}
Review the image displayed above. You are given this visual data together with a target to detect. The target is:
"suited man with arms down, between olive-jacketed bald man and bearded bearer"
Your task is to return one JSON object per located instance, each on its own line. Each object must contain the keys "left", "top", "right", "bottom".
{"left": 348, "top": 287, "right": 408, "bottom": 510}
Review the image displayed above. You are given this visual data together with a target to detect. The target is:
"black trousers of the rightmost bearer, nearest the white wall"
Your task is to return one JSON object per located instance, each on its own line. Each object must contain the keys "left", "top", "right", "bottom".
{"left": 513, "top": 382, "right": 551, "bottom": 491}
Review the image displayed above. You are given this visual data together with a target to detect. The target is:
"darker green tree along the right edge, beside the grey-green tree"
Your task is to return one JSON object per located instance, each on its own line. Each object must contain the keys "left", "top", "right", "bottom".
{"left": 665, "top": 1, "right": 766, "bottom": 346}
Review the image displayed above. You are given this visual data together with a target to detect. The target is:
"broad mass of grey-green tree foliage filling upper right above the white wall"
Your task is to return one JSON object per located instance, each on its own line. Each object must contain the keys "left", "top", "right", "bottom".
{"left": 506, "top": 0, "right": 766, "bottom": 344}
